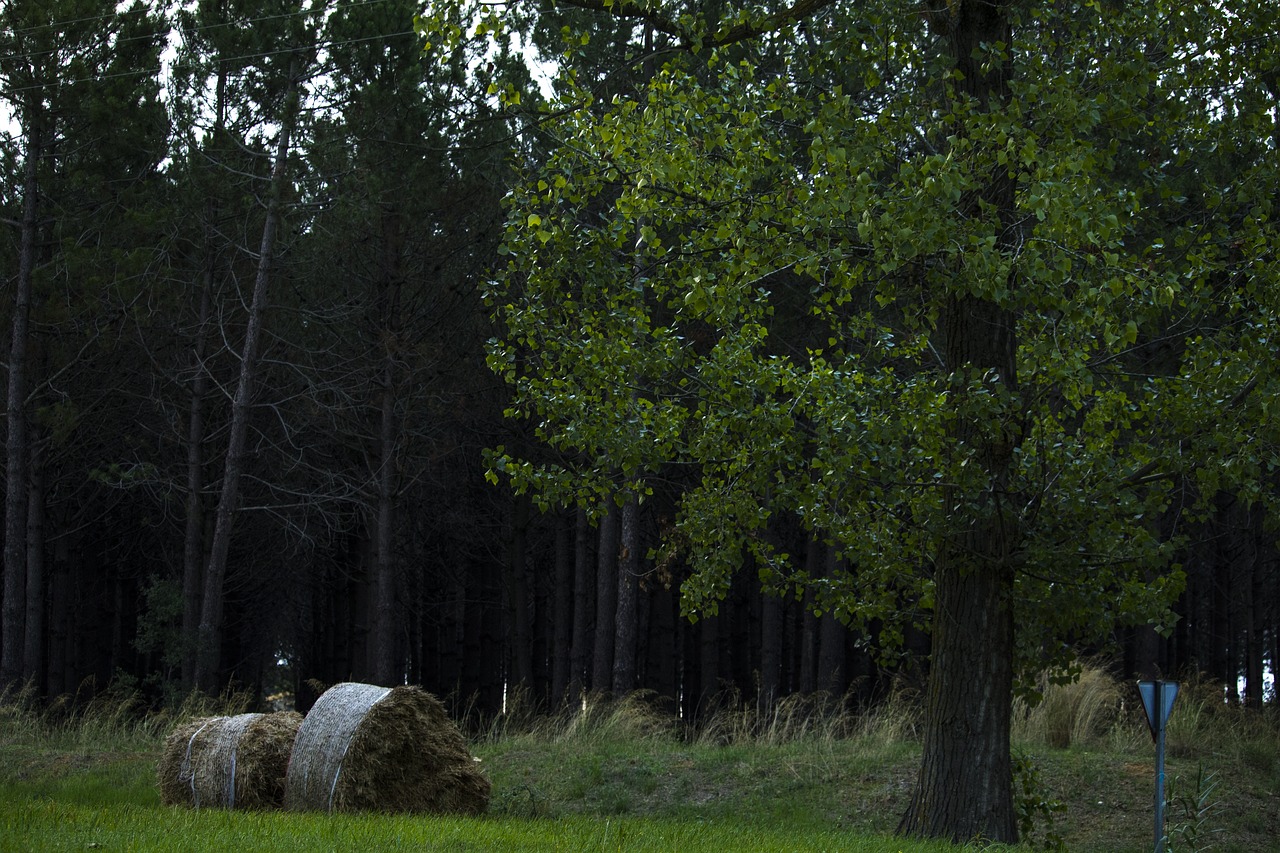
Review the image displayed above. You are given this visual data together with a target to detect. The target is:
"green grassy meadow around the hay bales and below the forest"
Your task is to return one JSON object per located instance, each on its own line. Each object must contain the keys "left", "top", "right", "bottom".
{"left": 0, "top": 669, "right": 1280, "bottom": 853}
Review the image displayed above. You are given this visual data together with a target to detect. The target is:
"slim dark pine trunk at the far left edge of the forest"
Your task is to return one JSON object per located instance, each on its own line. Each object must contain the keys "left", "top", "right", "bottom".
{"left": 0, "top": 122, "right": 41, "bottom": 692}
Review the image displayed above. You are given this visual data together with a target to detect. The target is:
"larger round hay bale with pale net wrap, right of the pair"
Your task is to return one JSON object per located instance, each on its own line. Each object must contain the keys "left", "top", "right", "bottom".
{"left": 284, "top": 683, "right": 489, "bottom": 815}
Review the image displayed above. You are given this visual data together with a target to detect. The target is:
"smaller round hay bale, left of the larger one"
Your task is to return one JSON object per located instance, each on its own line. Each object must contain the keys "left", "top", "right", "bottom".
{"left": 156, "top": 711, "right": 302, "bottom": 808}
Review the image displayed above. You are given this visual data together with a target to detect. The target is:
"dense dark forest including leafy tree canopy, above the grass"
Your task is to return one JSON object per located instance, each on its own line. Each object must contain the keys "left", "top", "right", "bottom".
{"left": 0, "top": 0, "right": 1280, "bottom": 835}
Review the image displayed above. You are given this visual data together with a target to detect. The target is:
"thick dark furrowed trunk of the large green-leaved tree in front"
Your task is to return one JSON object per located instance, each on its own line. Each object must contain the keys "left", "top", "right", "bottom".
{"left": 899, "top": 0, "right": 1019, "bottom": 844}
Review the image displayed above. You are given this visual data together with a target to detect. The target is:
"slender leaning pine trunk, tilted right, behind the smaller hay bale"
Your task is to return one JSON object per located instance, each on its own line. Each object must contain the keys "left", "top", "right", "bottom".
{"left": 195, "top": 69, "right": 300, "bottom": 693}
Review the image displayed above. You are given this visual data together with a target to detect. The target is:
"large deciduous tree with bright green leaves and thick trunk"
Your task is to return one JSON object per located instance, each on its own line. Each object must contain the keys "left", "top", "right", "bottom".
{"left": 473, "top": 0, "right": 1277, "bottom": 841}
